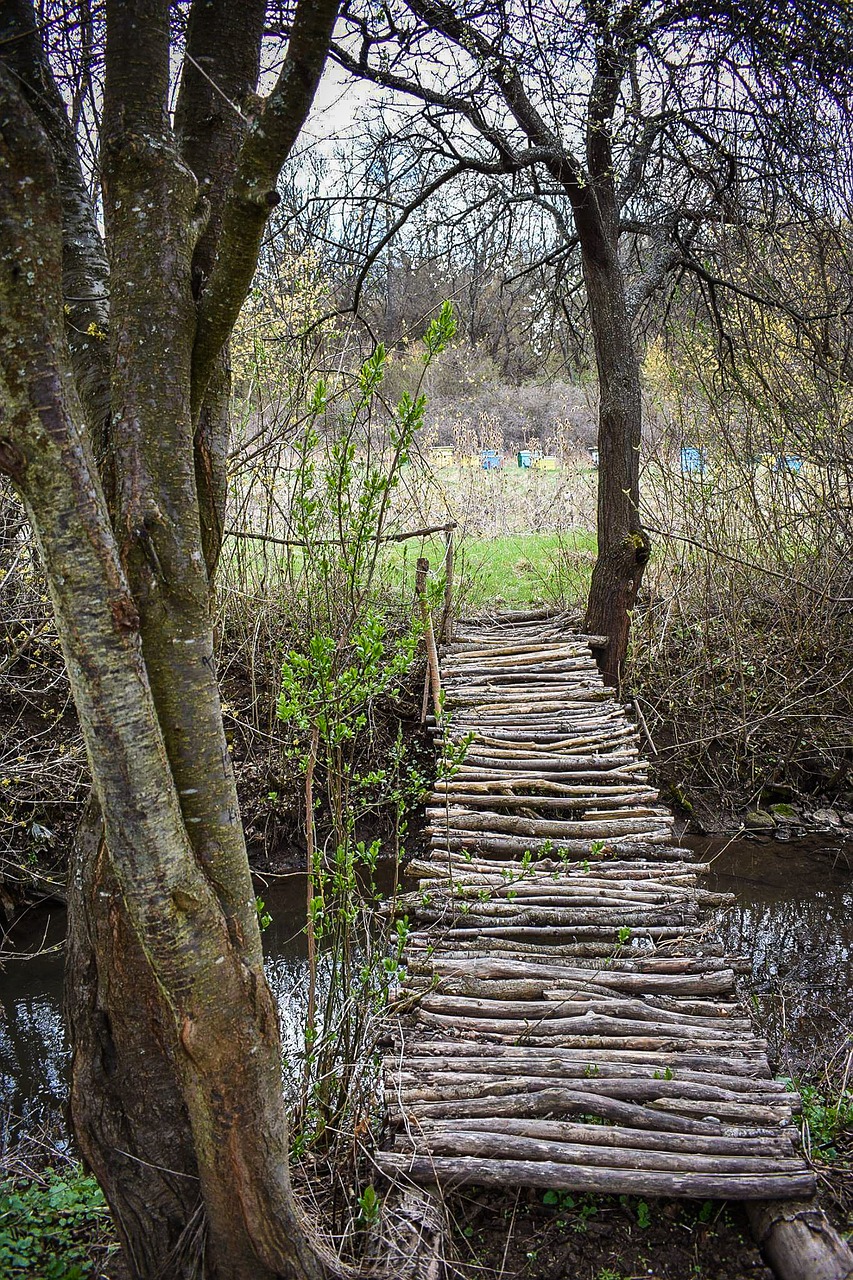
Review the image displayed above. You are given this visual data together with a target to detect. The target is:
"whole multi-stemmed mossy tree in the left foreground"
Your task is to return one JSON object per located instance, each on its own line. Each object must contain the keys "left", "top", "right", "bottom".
{"left": 0, "top": 0, "right": 337, "bottom": 1280}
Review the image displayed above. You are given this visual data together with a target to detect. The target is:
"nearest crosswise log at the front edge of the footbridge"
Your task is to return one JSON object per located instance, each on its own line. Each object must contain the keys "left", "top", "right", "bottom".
{"left": 375, "top": 1152, "right": 816, "bottom": 1199}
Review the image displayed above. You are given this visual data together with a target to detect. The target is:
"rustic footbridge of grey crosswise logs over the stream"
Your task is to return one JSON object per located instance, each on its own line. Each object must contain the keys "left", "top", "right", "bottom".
{"left": 377, "top": 617, "right": 815, "bottom": 1199}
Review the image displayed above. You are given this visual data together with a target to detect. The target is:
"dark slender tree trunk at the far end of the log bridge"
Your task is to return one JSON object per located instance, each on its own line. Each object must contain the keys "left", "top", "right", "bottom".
{"left": 583, "top": 237, "right": 649, "bottom": 686}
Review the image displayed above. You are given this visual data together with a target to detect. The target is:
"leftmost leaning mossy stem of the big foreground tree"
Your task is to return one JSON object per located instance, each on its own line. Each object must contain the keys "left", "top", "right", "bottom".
{"left": 0, "top": 85, "right": 321, "bottom": 1280}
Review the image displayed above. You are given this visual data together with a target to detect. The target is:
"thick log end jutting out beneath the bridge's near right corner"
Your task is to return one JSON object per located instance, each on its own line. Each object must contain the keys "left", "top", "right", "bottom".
{"left": 745, "top": 1201, "right": 853, "bottom": 1280}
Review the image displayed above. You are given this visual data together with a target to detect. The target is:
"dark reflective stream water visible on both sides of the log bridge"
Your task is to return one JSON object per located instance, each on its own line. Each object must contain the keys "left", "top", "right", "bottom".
{"left": 0, "top": 833, "right": 853, "bottom": 1137}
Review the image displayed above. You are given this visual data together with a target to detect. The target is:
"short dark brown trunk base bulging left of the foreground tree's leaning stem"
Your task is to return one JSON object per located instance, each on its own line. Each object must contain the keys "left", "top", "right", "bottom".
{"left": 65, "top": 800, "right": 206, "bottom": 1280}
